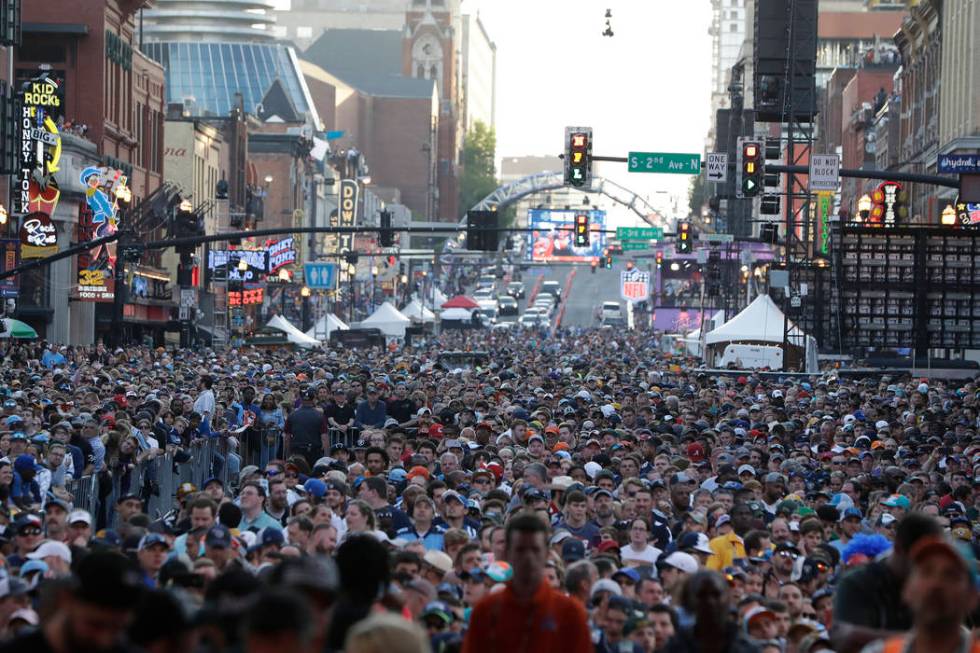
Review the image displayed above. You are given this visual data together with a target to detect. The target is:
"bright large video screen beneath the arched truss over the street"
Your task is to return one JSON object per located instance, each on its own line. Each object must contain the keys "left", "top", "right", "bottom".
{"left": 527, "top": 209, "right": 606, "bottom": 263}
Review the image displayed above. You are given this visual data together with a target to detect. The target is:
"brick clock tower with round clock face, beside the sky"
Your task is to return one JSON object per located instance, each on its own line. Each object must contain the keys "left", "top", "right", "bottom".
{"left": 402, "top": 0, "right": 464, "bottom": 221}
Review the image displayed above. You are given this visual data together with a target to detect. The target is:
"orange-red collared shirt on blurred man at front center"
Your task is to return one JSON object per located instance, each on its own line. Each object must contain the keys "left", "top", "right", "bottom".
{"left": 463, "top": 581, "right": 595, "bottom": 653}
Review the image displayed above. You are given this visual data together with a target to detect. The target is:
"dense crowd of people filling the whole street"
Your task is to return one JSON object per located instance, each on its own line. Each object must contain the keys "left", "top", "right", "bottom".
{"left": 0, "top": 330, "right": 980, "bottom": 653}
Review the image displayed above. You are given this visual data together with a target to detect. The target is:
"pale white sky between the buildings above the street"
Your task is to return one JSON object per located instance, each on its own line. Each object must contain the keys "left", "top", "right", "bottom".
{"left": 462, "top": 0, "right": 711, "bottom": 222}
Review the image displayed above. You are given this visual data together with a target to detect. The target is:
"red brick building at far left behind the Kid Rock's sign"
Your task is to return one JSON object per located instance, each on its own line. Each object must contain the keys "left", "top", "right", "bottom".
{"left": 14, "top": 0, "right": 170, "bottom": 343}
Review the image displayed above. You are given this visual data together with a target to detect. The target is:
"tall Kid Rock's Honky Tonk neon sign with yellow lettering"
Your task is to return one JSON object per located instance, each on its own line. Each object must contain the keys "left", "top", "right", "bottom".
{"left": 11, "top": 72, "right": 64, "bottom": 217}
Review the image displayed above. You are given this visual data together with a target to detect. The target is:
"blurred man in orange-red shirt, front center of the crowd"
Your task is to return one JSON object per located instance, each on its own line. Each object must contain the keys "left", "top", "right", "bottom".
{"left": 463, "top": 513, "right": 594, "bottom": 653}
